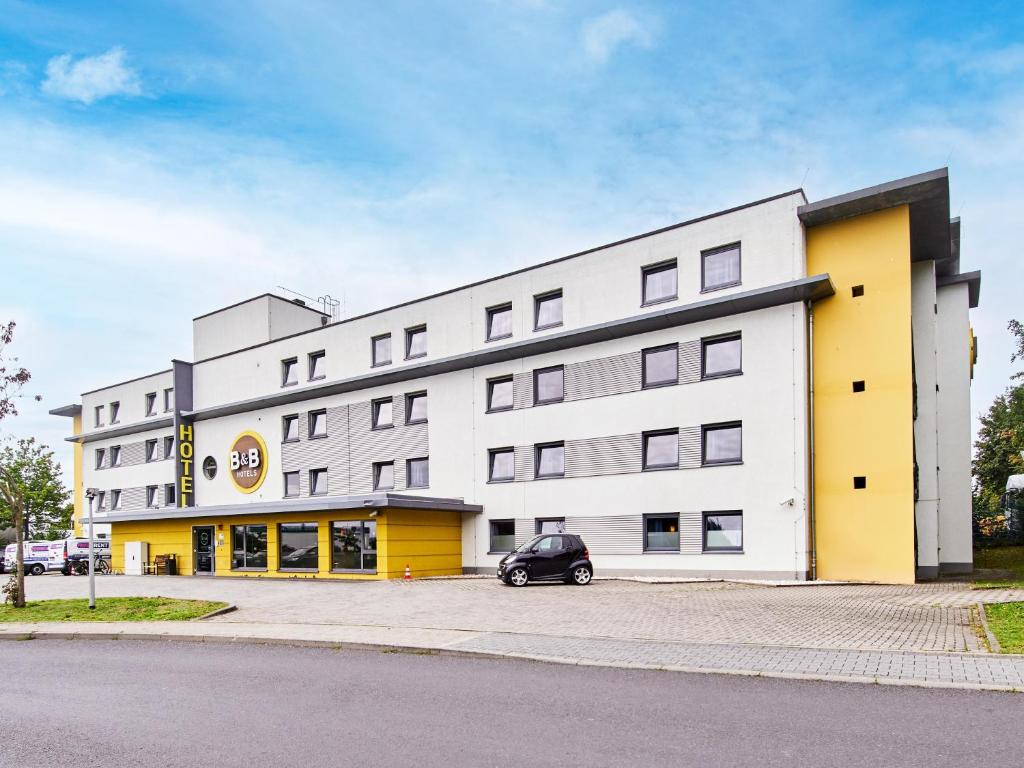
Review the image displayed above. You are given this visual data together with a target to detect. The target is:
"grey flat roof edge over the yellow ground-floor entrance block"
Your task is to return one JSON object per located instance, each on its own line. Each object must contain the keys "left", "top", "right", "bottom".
{"left": 96, "top": 494, "right": 483, "bottom": 523}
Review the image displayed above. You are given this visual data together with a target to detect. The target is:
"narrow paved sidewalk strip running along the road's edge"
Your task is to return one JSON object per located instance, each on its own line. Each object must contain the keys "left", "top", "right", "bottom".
{"left": 0, "top": 622, "right": 1024, "bottom": 691}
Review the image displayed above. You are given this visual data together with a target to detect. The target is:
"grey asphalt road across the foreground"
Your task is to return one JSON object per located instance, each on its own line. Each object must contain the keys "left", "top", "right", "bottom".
{"left": 0, "top": 640, "right": 1024, "bottom": 768}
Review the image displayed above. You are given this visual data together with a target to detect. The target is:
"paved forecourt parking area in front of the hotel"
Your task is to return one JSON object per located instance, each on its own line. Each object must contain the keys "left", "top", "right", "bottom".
{"left": 27, "top": 574, "right": 1024, "bottom": 652}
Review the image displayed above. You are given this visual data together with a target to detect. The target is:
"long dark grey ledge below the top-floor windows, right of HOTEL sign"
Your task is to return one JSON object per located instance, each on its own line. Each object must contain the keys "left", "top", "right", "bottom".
{"left": 186, "top": 274, "right": 835, "bottom": 421}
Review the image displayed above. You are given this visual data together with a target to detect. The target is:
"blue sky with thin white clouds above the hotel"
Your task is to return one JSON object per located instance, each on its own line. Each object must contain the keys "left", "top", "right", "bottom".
{"left": 0, "top": 0, "right": 1024, "bottom": 481}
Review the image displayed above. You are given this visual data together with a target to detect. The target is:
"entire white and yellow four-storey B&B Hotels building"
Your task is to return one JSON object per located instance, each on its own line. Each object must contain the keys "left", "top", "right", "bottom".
{"left": 54, "top": 170, "right": 980, "bottom": 582}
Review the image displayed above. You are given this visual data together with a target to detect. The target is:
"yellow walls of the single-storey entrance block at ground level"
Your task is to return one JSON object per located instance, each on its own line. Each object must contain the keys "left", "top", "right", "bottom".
{"left": 112, "top": 509, "right": 462, "bottom": 580}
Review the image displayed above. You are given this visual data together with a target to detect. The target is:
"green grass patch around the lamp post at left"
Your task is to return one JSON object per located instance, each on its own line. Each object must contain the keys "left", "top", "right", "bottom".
{"left": 0, "top": 597, "right": 227, "bottom": 623}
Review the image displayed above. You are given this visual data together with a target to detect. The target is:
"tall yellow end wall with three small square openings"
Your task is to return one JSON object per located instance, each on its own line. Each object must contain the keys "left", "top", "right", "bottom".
{"left": 807, "top": 206, "right": 914, "bottom": 584}
